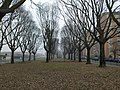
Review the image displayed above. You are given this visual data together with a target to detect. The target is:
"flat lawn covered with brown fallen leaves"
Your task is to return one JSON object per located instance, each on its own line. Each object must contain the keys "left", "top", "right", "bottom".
{"left": 0, "top": 61, "right": 120, "bottom": 90}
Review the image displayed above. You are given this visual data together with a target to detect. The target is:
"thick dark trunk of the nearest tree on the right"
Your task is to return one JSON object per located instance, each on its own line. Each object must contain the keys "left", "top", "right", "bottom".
{"left": 99, "top": 43, "right": 106, "bottom": 67}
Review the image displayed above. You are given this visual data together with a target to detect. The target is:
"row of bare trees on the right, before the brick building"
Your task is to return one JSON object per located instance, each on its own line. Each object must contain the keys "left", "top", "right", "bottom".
{"left": 60, "top": 0, "right": 120, "bottom": 67}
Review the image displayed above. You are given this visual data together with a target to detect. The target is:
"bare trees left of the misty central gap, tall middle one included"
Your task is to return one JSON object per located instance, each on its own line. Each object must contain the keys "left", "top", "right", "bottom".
{"left": 0, "top": 0, "right": 59, "bottom": 63}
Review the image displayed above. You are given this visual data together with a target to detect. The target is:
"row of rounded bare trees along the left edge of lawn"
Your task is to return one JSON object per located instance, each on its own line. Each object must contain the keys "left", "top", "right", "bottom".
{"left": 0, "top": 7, "right": 42, "bottom": 63}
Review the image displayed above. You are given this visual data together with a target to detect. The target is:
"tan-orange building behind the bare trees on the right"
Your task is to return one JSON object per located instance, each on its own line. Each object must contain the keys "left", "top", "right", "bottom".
{"left": 82, "top": 12, "right": 120, "bottom": 59}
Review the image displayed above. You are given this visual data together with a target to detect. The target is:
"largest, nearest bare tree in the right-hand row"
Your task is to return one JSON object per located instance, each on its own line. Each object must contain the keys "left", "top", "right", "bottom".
{"left": 63, "top": 0, "right": 119, "bottom": 67}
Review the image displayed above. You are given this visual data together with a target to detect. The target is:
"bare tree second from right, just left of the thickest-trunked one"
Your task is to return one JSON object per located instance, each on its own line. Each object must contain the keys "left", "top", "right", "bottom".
{"left": 60, "top": 2, "right": 95, "bottom": 64}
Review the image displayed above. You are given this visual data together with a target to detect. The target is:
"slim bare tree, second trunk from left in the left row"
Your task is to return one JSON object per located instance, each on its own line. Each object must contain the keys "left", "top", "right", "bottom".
{"left": 19, "top": 8, "right": 32, "bottom": 62}
